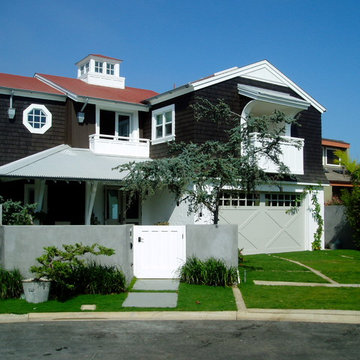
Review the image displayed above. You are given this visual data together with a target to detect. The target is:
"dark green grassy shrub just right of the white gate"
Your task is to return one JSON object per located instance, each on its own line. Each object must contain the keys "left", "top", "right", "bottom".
{"left": 179, "top": 257, "right": 237, "bottom": 286}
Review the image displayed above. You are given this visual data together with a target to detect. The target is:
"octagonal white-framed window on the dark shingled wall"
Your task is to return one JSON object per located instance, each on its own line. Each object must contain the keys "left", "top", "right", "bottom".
{"left": 23, "top": 104, "right": 52, "bottom": 134}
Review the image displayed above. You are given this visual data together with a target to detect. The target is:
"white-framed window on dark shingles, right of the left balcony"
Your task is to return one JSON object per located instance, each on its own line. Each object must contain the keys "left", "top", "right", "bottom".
{"left": 152, "top": 105, "right": 175, "bottom": 144}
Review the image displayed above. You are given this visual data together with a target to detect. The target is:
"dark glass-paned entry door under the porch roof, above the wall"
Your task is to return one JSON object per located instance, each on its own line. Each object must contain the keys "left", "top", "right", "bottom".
{"left": 105, "top": 188, "right": 140, "bottom": 225}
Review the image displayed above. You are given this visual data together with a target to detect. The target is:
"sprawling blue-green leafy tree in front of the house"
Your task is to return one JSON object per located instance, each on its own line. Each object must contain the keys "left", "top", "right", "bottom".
{"left": 116, "top": 99, "right": 300, "bottom": 224}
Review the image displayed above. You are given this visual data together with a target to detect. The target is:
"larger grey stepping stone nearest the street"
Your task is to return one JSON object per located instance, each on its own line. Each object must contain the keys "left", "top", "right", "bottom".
{"left": 123, "top": 292, "right": 177, "bottom": 308}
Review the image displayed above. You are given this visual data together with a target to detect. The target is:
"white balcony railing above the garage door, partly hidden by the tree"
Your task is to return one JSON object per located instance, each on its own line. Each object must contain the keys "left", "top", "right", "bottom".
{"left": 252, "top": 133, "right": 304, "bottom": 175}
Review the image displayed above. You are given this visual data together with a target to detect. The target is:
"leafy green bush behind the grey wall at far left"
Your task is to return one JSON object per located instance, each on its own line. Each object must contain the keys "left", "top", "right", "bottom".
{"left": 0, "top": 196, "right": 36, "bottom": 225}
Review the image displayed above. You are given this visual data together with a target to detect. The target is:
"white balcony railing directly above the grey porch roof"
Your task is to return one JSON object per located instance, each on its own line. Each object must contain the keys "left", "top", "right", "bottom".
{"left": 89, "top": 134, "right": 150, "bottom": 158}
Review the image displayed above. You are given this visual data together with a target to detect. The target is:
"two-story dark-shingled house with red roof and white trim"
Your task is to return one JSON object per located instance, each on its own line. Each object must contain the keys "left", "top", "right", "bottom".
{"left": 0, "top": 54, "right": 327, "bottom": 253}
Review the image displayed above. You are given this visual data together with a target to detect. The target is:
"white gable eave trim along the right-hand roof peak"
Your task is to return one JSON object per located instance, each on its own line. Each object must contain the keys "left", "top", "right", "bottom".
{"left": 147, "top": 60, "right": 326, "bottom": 113}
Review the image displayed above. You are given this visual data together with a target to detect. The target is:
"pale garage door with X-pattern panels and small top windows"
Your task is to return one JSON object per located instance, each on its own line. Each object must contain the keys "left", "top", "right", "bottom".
{"left": 219, "top": 191, "right": 305, "bottom": 254}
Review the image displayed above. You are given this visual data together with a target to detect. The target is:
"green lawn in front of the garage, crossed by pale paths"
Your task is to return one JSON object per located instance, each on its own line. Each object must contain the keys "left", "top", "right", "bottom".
{"left": 240, "top": 250, "right": 360, "bottom": 310}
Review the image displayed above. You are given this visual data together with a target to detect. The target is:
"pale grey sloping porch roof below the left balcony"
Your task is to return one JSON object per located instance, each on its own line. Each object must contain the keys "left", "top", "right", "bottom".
{"left": 0, "top": 145, "right": 149, "bottom": 182}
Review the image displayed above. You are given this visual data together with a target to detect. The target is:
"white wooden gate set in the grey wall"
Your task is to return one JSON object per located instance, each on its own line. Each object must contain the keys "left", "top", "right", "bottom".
{"left": 133, "top": 226, "right": 186, "bottom": 279}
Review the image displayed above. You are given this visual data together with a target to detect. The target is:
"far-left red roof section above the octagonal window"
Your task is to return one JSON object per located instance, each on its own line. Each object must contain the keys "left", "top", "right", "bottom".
{"left": 0, "top": 73, "right": 64, "bottom": 95}
